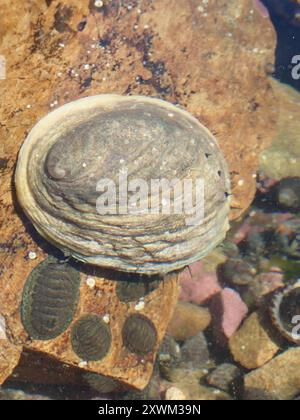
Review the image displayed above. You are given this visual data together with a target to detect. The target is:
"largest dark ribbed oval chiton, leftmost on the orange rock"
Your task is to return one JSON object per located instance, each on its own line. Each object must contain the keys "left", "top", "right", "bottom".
{"left": 21, "top": 258, "right": 80, "bottom": 340}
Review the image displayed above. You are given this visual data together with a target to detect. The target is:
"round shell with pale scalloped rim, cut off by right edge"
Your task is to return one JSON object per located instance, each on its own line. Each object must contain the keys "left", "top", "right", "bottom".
{"left": 270, "top": 281, "right": 300, "bottom": 345}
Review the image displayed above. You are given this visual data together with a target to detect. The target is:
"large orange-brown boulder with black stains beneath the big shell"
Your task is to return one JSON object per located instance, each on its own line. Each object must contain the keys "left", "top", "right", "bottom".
{"left": 0, "top": 0, "right": 276, "bottom": 388}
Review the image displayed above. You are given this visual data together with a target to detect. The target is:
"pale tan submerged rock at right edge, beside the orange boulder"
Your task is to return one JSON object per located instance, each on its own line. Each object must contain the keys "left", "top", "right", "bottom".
{"left": 260, "top": 79, "right": 300, "bottom": 180}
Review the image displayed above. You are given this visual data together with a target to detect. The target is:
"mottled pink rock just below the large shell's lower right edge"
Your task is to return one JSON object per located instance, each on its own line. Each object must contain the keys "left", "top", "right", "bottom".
{"left": 179, "top": 261, "right": 222, "bottom": 305}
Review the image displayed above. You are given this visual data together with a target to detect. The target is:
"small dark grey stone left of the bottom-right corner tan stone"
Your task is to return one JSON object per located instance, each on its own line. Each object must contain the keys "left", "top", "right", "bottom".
{"left": 206, "top": 363, "right": 242, "bottom": 392}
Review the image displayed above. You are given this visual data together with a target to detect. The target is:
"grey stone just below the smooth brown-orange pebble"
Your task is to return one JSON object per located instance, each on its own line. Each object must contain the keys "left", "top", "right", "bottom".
{"left": 181, "top": 332, "right": 209, "bottom": 369}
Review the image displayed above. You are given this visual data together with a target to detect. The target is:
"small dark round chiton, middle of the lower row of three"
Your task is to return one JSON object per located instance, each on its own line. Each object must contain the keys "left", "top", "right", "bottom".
{"left": 71, "top": 314, "right": 111, "bottom": 362}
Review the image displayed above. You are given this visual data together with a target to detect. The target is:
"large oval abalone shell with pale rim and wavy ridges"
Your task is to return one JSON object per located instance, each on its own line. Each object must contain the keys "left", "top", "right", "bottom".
{"left": 16, "top": 95, "right": 230, "bottom": 274}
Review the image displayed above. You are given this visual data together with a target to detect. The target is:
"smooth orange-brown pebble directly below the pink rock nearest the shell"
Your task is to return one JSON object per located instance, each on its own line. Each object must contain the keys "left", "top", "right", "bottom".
{"left": 168, "top": 302, "right": 211, "bottom": 341}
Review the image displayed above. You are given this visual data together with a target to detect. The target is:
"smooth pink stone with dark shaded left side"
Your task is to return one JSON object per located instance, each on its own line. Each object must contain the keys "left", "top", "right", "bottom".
{"left": 210, "top": 288, "right": 248, "bottom": 343}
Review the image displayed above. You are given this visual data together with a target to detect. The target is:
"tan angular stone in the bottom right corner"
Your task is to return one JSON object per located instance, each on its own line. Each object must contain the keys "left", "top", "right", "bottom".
{"left": 245, "top": 348, "right": 300, "bottom": 400}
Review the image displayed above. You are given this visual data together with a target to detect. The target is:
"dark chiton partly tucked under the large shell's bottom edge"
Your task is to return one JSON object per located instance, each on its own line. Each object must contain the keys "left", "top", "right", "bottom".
{"left": 116, "top": 273, "right": 162, "bottom": 303}
